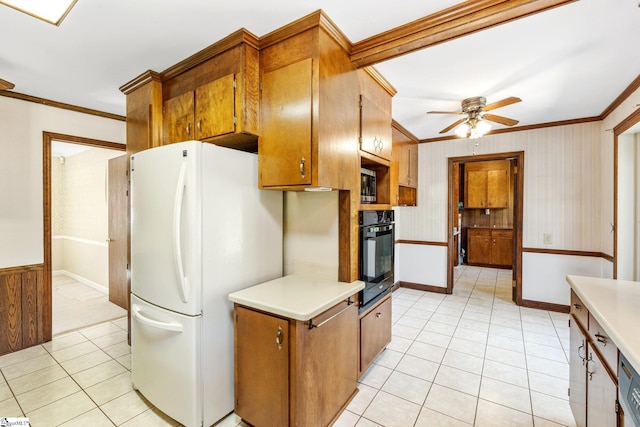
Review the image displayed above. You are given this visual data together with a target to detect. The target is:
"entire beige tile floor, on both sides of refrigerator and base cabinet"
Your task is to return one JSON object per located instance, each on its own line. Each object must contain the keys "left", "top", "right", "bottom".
{"left": 0, "top": 266, "right": 574, "bottom": 427}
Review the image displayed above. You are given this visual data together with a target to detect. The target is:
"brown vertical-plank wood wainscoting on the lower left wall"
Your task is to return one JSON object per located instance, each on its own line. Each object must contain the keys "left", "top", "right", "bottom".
{"left": 0, "top": 264, "right": 51, "bottom": 355}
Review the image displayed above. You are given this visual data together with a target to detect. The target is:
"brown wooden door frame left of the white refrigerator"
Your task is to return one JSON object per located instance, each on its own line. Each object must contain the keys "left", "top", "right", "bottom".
{"left": 42, "top": 131, "right": 127, "bottom": 341}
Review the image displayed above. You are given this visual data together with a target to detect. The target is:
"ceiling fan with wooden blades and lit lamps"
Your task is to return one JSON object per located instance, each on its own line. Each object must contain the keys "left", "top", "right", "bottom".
{"left": 427, "top": 96, "right": 522, "bottom": 139}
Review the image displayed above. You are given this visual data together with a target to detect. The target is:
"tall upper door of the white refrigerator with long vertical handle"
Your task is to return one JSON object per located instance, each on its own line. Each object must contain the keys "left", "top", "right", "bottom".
{"left": 131, "top": 141, "right": 202, "bottom": 316}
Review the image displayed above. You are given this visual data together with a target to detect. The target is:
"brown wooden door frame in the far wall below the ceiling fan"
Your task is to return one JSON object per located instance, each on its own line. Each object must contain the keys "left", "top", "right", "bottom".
{"left": 446, "top": 151, "right": 524, "bottom": 305}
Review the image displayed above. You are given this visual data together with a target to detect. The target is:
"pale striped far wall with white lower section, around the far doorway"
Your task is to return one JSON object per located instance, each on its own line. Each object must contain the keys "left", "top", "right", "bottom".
{"left": 396, "top": 122, "right": 604, "bottom": 305}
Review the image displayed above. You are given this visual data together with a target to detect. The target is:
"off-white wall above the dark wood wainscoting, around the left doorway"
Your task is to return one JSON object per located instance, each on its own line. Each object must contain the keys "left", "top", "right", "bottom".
{"left": 0, "top": 95, "right": 126, "bottom": 268}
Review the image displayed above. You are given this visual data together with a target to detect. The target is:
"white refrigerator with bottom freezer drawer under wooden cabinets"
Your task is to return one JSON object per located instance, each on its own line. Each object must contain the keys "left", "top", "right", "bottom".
{"left": 130, "top": 141, "right": 282, "bottom": 427}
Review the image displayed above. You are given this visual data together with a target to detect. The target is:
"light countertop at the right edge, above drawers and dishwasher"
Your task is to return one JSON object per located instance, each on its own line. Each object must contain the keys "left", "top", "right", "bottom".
{"left": 567, "top": 276, "right": 640, "bottom": 371}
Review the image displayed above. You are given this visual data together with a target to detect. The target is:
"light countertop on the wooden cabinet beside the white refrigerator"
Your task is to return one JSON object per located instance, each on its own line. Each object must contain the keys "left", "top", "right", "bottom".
{"left": 229, "top": 274, "right": 364, "bottom": 321}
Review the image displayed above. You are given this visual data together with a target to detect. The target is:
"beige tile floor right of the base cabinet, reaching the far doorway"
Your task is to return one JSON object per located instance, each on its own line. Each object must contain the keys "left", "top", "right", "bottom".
{"left": 335, "top": 266, "right": 575, "bottom": 427}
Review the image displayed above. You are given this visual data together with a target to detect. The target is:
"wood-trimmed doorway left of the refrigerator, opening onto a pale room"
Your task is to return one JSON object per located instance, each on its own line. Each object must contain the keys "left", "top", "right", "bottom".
{"left": 43, "top": 132, "right": 126, "bottom": 334}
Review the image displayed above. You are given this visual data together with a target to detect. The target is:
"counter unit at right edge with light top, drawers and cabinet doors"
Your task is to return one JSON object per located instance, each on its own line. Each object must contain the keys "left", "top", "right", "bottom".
{"left": 567, "top": 275, "right": 640, "bottom": 427}
